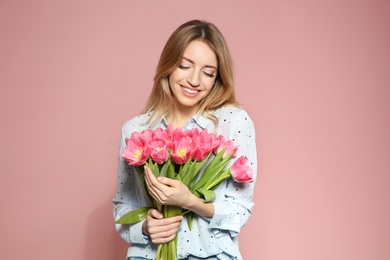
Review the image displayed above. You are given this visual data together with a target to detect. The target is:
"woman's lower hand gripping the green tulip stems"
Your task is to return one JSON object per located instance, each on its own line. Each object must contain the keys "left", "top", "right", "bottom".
{"left": 142, "top": 209, "right": 183, "bottom": 244}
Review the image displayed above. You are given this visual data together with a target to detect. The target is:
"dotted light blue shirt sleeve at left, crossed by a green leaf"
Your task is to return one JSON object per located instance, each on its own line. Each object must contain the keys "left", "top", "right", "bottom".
{"left": 112, "top": 122, "right": 150, "bottom": 244}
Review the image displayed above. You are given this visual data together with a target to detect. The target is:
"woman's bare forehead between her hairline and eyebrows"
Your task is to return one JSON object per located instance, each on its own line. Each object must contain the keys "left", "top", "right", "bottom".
{"left": 183, "top": 40, "right": 218, "bottom": 67}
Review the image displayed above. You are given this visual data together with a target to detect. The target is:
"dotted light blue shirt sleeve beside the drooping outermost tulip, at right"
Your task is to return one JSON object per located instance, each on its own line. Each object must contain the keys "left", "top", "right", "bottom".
{"left": 209, "top": 109, "right": 257, "bottom": 237}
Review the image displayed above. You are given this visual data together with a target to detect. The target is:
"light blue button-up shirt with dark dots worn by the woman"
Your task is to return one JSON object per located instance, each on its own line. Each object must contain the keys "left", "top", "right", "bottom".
{"left": 113, "top": 106, "right": 257, "bottom": 259}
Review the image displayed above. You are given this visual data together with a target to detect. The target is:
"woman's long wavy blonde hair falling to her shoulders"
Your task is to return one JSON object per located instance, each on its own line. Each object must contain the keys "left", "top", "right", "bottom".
{"left": 143, "top": 20, "right": 238, "bottom": 124}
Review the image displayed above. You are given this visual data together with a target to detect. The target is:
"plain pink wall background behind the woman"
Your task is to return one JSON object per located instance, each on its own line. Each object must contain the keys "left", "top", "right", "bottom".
{"left": 0, "top": 0, "right": 390, "bottom": 260}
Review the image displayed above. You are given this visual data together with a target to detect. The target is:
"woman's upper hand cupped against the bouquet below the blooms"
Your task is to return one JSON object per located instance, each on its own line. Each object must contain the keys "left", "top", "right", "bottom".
{"left": 144, "top": 166, "right": 193, "bottom": 209}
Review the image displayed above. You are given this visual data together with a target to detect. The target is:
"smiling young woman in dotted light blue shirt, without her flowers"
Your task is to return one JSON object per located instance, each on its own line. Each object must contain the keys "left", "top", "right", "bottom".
{"left": 113, "top": 20, "right": 257, "bottom": 259}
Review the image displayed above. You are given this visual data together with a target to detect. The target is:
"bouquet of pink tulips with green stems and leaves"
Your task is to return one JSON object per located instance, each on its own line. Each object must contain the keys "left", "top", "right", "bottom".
{"left": 116, "top": 126, "right": 253, "bottom": 260}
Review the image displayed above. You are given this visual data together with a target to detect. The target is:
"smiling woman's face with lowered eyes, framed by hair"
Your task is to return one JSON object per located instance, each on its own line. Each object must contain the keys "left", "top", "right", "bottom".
{"left": 169, "top": 40, "right": 218, "bottom": 112}
